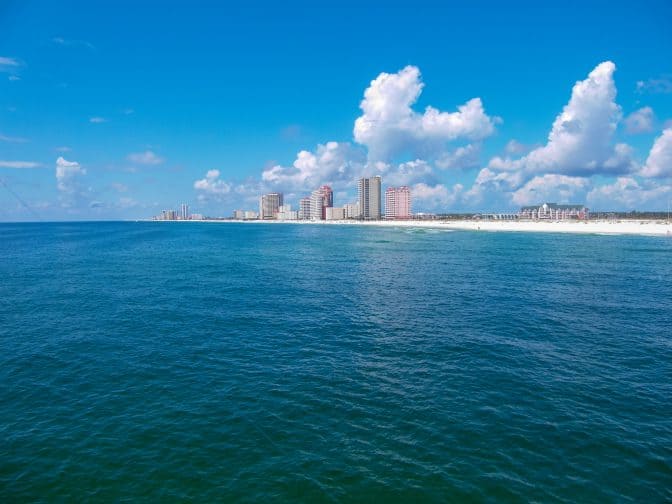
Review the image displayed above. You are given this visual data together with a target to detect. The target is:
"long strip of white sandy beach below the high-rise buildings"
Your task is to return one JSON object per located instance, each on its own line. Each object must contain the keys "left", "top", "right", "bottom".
{"left": 155, "top": 219, "right": 672, "bottom": 237}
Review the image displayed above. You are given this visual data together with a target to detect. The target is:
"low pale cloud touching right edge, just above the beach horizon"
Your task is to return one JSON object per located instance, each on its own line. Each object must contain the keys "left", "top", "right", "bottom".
{"left": 587, "top": 177, "right": 672, "bottom": 210}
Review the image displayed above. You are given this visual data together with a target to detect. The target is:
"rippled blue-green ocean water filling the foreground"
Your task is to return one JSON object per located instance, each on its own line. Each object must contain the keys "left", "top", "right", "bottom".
{"left": 0, "top": 223, "right": 672, "bottom": 503}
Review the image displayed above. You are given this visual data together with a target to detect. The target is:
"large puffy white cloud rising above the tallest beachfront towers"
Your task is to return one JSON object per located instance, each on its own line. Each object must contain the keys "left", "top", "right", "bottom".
{"left": 354, "top": 66, "right": 495, "bottom": 161}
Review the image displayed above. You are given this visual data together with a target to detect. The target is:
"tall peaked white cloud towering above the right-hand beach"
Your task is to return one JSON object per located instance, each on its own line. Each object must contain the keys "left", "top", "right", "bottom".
{"left": 488, "top": 61, "right": 632, "bottom": 177}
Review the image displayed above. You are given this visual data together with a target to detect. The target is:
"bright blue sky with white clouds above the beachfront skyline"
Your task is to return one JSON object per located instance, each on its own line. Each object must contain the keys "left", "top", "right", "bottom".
{"left": 0, "top": 0, "right": 672, "bottom": 221}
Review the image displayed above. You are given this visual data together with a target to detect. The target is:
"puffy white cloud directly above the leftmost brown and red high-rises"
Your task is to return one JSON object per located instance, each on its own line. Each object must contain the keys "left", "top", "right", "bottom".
{"left": 261, "top": 142, "right": 365, "bottom": 191}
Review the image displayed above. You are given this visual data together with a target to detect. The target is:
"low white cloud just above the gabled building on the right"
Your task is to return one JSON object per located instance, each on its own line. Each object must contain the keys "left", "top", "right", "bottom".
{"left": 511, "top": 174, "right": 591, "bottom": 206}
